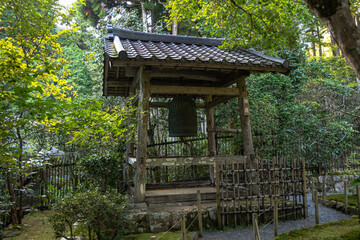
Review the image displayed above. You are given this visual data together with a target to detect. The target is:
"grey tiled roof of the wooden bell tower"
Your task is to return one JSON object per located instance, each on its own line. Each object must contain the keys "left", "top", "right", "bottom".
{"left": 104, "top": 26, "right": 292, "bottom": 72}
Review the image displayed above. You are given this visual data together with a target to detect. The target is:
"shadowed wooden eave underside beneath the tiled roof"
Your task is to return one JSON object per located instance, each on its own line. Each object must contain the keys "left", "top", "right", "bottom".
{"left": 103, "top": 60, "right": 286, "bottom": 102}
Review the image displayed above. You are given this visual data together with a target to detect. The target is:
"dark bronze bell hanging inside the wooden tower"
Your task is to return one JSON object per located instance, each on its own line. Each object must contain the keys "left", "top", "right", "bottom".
{"left": 169, "top": 96, "right": 197, "bottom": 137}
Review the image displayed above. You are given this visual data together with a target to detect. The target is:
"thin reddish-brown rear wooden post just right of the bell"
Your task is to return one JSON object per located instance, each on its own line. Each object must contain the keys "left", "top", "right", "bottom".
{"left": 205, "top": 98, "right": 216, "bottom": 183}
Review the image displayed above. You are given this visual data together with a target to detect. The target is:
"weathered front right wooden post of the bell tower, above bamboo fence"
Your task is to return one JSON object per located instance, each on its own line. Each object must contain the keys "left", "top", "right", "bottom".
{"left": 236, "top": 76, "right": 254, "bottom": 157}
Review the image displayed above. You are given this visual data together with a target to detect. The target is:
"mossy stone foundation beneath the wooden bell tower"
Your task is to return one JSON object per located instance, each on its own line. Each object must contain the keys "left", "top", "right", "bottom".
{"left": 128, "top": 202, "right": 303, "bottom": 233}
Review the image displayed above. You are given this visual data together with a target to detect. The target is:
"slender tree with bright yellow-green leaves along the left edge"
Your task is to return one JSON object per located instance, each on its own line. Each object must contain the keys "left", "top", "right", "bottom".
{"left": 0, "top": 0, "right": 75, "bottom": 224}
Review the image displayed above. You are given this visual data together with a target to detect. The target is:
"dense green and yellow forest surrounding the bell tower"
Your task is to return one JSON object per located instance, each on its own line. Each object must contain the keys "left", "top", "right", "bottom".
{"left": 0, "top": 0, "right": 360, "bottom": 232}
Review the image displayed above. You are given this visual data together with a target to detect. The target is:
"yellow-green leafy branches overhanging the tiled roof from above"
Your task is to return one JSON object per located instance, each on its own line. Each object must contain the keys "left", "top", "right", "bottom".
{"left": 167, "top": 0, "right": 311, "bottom": 51}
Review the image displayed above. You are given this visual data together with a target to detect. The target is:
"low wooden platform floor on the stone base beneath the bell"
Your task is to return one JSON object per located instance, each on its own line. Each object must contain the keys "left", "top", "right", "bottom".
{"left": 145, "top": 181, "right": 216, "bottom": 204}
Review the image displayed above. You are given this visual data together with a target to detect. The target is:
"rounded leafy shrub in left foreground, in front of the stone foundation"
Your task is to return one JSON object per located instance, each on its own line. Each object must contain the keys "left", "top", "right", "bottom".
{"left": 51, "top": 189, "right": 130, "bottom": 239}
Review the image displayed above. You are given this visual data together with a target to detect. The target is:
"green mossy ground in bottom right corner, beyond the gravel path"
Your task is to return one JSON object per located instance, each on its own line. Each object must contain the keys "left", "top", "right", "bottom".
{"left": 274, "top": 217, "right": 360, "bottom": 240}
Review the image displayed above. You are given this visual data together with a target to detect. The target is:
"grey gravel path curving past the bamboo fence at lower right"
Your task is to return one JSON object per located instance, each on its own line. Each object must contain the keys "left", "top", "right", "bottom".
{"left": 200, "top": 195, "right": 350, "bottom": 240}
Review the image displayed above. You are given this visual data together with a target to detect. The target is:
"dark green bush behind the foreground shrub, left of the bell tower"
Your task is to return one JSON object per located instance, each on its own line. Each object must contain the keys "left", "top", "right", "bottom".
{"left": 77, "top": 151, "right": 124, "bottom": 192}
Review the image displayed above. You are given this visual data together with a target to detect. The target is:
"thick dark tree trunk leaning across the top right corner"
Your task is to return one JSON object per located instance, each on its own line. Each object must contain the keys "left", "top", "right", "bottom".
{"left": 305, "top": 0, "right": 360, "bottom": 77}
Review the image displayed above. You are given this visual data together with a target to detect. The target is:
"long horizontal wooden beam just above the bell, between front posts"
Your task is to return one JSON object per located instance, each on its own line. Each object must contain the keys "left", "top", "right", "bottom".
{"left": 150, "top": 85, "right": 239, "bottom": 96}
